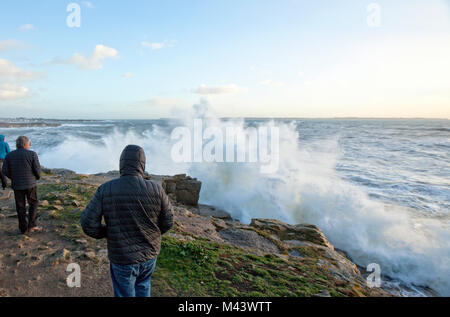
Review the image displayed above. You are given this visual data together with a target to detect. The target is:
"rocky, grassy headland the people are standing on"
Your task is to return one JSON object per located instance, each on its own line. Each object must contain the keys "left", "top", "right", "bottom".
{"left": 0, "top": 168, "right": 438, "bottom": 297}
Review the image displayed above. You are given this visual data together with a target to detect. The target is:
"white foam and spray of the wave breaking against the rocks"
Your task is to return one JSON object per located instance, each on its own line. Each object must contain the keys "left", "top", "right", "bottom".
{"left": 41, "top": 115, "right": 450, "bottom": 296}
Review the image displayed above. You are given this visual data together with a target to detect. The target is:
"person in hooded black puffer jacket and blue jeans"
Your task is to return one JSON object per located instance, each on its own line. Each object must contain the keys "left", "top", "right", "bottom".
{"left": 81, "top": 145, "right": 173, "bottom": 297}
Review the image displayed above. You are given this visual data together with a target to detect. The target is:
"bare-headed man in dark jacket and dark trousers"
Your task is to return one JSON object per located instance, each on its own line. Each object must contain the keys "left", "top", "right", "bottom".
{"left": 2, "top": 136, "right": 42, "bottom": 234}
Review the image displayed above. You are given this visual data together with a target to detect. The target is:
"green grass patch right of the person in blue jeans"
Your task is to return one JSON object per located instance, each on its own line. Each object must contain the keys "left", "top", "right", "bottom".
{"left": 152, "top": 237, "right": 354, "bottom": 296}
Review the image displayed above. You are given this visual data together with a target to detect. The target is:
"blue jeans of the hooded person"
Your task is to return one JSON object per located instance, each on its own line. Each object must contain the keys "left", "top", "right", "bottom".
{"left": 110, "top": 258, "right": 156, "bottom": 297}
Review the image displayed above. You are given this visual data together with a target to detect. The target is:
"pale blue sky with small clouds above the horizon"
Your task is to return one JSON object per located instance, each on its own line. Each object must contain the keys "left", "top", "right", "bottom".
{"left": 0, "top": 0, "right": 450, "bottom": 119}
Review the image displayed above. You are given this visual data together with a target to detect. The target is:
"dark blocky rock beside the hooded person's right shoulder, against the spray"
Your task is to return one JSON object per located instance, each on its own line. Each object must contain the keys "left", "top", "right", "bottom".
{"left": 161, "top": 174, "right": 202, "bottom": 206}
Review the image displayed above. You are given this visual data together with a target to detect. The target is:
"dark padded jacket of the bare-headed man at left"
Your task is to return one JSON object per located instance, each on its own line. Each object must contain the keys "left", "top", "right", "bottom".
{"left": 2, "top": 148, "right": 41, "bottom": 190}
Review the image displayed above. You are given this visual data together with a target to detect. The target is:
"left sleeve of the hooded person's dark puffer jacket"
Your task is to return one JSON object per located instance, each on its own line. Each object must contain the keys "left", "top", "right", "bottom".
{"left": 81, "top": 188, "right": 106, "bottom": 239}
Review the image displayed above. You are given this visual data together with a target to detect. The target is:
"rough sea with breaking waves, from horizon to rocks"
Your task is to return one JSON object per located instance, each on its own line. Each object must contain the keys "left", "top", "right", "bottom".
{"left": 0, "top": 115, "right": 450, "bottom": 296}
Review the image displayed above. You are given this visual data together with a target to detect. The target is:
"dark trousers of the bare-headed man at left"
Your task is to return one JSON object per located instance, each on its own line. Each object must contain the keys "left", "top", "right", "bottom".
{"left": 14, "top": 187, "right": 39, "bottom": 233}
